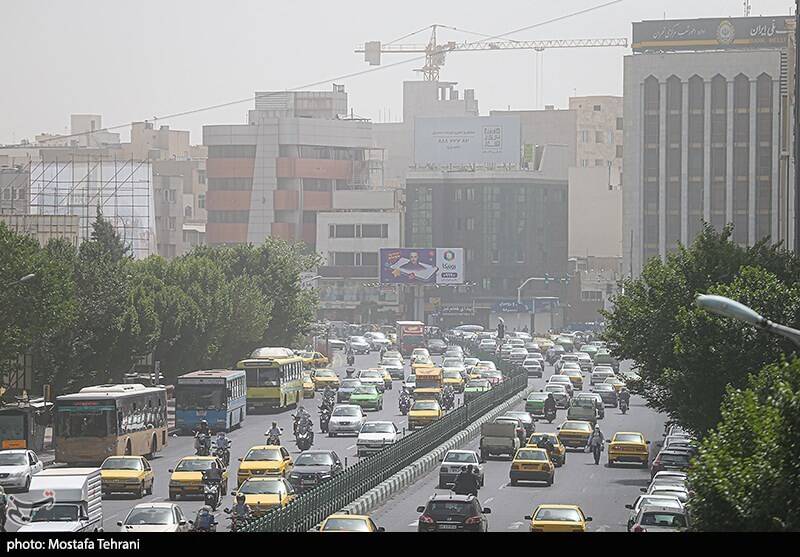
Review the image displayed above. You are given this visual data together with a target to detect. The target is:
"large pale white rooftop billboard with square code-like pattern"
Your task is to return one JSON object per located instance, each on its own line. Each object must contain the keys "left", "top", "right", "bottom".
{"left": 414, "top": 116, "right": 520, "bottom": 165}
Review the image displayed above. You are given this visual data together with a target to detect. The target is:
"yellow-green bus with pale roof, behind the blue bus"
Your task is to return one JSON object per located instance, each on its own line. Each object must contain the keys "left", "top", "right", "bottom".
{"left": 236, "top": 347, "right": 303, "bottom": 410}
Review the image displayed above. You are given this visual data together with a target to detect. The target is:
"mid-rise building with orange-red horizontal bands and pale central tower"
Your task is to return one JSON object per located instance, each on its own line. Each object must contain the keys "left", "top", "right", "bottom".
{"left": 203, "top": 85, "right": 381, "bottom": 246}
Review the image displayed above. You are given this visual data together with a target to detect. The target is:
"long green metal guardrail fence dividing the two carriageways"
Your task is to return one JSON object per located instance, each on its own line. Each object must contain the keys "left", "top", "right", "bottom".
{"left": 238, "top": 338, "right": 528, "bottom": 532}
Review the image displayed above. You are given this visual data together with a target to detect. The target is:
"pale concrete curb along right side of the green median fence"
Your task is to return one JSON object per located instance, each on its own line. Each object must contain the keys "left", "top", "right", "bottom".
{"left": 334, "top": 386, "right": 535, "bottom": 514}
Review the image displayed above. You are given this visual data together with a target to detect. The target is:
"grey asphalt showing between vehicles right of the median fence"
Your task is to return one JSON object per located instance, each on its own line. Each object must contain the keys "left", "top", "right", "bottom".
{"left": 371, "top": 363, "right": 665, "bottom": 532}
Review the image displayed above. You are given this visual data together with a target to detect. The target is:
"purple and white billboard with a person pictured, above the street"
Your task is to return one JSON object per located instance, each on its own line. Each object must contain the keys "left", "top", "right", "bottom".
{"left": 380, "top": 248, "right": 464, "bottom": 285}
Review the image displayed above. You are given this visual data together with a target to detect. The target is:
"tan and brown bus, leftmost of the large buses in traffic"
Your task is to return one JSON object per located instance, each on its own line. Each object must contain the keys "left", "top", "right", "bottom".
{"left": 53, "top": 383, "right": 167, "bottom": 466}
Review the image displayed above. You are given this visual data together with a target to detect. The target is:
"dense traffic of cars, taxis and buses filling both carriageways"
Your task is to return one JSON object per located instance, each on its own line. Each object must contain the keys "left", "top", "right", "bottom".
{"left": 0, "top": 322, "right": 693, "bottom": 532}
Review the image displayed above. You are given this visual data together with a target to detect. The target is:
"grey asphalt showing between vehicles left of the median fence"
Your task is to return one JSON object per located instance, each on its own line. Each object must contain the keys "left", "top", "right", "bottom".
{"left": 98, "top": 351, "right": 444, "bottom": 532}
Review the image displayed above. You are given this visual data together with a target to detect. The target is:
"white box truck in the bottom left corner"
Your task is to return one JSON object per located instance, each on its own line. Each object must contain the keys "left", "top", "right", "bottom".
{"left": 18, "top": 468, "right": 103, "bottom": 532}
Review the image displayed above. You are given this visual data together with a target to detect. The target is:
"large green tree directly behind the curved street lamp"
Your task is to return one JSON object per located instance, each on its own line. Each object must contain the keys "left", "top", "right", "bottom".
{"left": 604, "top": 225, "right": 800, "bottom": 433}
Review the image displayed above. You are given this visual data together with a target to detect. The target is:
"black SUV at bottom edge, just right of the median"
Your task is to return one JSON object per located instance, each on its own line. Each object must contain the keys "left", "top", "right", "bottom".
{"left": 417, "top": 493, "right": 492, "bottom": 532}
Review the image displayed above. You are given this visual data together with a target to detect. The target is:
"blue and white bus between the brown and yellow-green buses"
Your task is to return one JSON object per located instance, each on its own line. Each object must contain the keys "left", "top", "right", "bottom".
{"left": 175, "top": 369, "right": 247, "bottom": 433}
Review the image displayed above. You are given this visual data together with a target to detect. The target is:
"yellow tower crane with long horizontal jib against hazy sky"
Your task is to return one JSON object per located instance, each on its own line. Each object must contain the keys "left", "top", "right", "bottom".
{"left": 355, "top": 24, "right": 628, "bottom": 81}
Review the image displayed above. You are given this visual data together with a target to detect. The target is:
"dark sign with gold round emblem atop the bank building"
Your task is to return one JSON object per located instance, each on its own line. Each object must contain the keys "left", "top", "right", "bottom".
{"left": 633, "top": 16, "right": 791, "bottom": 51}
